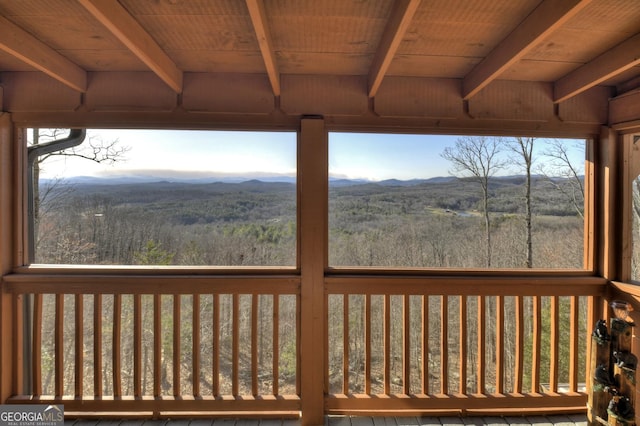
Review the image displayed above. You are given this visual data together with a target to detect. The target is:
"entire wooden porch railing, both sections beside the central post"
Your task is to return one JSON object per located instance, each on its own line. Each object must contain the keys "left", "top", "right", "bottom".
{"left": 4, "top": 274, "right": 606, "bottom": 418}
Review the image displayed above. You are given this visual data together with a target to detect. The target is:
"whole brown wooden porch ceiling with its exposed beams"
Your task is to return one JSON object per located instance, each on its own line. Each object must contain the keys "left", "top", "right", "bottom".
{"left": 0, "top": 0, "right": 640, "bottom": 131}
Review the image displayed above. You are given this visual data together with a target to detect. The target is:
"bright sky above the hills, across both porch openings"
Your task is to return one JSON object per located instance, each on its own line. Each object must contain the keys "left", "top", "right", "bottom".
{"left": 33, "top": 129, "right": 584, "bottom": 181}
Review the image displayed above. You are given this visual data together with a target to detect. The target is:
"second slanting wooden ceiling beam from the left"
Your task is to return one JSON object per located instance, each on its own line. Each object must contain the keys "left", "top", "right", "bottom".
{"left": 78, "top": 0, "right": 183, "bottom": 93}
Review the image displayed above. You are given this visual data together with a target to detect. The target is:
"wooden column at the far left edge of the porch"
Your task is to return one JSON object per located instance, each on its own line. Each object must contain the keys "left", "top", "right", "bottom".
{"left": 0, "top": 111, "right": 15, "bottom": 403}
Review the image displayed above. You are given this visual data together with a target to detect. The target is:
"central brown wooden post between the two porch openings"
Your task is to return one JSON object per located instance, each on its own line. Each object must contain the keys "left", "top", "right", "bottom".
{"left": 298, "top": 118, "right": 329, "bottom": 425}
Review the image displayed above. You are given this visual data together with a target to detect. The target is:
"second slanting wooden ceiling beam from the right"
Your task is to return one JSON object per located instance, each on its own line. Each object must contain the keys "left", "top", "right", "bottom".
{"left": 462, "top": 0, "right": 591, "bottom": 100}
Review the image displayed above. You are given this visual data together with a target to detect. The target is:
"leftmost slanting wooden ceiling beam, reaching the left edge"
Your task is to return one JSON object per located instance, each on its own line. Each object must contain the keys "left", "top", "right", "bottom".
{"left": 0, "top": 16, "right": 87, "bottom": 92}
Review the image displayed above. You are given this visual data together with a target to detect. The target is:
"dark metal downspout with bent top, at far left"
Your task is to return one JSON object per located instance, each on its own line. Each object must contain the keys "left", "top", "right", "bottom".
{"left": 23, "top": 129, "right": 87, "bottom": 394}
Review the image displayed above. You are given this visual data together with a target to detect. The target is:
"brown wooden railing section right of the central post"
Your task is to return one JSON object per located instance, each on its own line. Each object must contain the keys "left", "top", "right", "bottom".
{"left": 325, "top": 277, "right": 604, "bottom": 415}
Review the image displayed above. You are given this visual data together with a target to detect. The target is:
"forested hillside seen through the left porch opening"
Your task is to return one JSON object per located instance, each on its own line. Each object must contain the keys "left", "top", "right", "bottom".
{"left": 36, "top": 181, "right": 296, "bottom": 265}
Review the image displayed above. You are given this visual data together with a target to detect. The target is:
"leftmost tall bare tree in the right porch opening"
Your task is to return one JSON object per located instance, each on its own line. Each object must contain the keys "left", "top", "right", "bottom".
{"left": 442, "top": 136, "right": 506, "bottom": 268}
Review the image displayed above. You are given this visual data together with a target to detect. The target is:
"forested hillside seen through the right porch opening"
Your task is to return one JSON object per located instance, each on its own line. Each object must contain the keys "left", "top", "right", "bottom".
{"left": 329, "top": 176, "right": 584, "bottom": 268}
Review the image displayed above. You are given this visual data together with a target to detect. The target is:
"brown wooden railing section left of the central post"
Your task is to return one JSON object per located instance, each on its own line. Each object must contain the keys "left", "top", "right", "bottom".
{"left": 2, "top": 276, "right": 300, "bottom": 418}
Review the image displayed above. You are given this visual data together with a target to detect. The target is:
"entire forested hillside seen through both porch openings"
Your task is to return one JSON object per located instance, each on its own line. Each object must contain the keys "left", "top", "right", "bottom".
{"left": 36, "top": 176, "right": 583, "bottom": 268}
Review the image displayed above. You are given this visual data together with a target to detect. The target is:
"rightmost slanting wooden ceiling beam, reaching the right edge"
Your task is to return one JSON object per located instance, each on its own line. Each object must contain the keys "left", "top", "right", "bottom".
{"left": 553, "top": 33, "right": 640, "bottom": 103}
